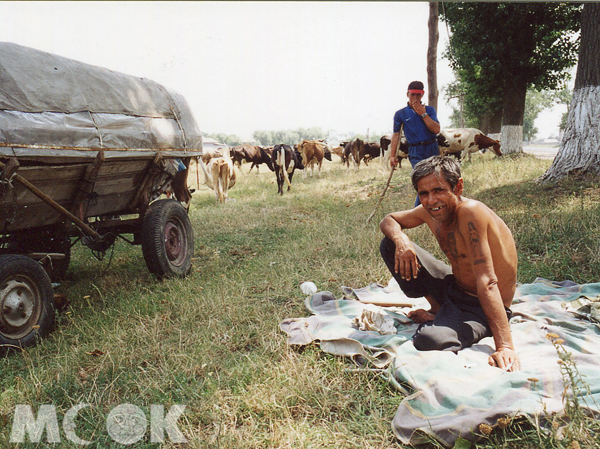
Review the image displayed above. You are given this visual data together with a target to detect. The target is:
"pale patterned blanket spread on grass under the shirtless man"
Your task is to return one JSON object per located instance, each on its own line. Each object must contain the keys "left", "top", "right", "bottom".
{"left": 280, "top": 279, "right": 600, "bottom": 447}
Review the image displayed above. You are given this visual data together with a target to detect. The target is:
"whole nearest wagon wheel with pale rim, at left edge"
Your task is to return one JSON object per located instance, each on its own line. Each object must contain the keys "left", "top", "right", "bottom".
{"left": 0, "top": 254, "right": 55, "bottom": 353}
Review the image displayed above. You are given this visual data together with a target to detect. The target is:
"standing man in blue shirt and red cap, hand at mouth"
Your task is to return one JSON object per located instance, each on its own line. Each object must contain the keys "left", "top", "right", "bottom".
{"left": 390, "top": 81, "right": 440, "bottom": 207}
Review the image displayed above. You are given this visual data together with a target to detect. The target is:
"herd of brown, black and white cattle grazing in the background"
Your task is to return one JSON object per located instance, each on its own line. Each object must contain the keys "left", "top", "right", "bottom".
{"left": 199, "top": 128, "right": 502, "bottom": 203}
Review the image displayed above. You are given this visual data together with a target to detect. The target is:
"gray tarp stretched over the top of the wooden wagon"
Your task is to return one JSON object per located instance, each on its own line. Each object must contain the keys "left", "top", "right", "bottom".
{"left": 0, "top": 42, "right": 202, "bottom": 157}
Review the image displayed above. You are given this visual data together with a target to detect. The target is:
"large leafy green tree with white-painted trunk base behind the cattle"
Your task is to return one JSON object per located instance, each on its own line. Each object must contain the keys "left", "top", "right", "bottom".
{"left": 442, "top": 2, "right": 581, "bottom": 153}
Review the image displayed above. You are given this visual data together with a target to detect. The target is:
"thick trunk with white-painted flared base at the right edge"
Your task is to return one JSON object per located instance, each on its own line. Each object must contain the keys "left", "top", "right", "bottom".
{"left": 539, "top": 3, "right": 600, "bottom": 182}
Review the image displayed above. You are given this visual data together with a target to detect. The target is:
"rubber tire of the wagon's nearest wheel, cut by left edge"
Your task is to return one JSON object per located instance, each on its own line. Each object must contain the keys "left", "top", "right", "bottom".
{"left": 0, "top": 254, "right": 56, "bottom": 354}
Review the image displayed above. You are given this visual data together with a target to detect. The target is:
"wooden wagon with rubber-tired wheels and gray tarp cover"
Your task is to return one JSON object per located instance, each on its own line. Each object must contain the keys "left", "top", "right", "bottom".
{"left": 0, "top": 43, "right": 202, "bottom": 347}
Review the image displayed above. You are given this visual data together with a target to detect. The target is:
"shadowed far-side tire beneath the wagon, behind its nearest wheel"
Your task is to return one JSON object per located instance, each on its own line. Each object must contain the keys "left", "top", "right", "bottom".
{"left": 8, "top": 229, "right": 71, "bottom": 282}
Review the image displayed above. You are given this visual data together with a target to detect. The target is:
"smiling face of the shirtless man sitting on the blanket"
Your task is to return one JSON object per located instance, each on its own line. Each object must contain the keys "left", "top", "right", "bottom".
{"left": 417, "top": 173, "right": 463, "bottom": 223}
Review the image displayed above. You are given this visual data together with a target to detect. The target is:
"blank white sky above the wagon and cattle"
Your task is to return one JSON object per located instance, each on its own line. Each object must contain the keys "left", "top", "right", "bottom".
{"left": 0, "top": 1, "right": 560, "bottom": 138}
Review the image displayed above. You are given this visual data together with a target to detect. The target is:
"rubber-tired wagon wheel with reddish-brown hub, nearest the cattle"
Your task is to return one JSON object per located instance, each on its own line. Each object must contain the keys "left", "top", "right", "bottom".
{"left": 142, "top": 199, "right": 194, "bottom": 279}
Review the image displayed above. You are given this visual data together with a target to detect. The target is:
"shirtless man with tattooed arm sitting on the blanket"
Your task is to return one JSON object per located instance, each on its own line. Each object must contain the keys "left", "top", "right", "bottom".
{"left": 380, "top": 156, "right": 520, "bottom": 371}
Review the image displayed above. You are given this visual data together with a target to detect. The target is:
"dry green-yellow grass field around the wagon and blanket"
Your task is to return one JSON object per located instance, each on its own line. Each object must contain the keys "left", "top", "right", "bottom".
{"left": 0, "top": 155, "right": 600, "bottom": 449}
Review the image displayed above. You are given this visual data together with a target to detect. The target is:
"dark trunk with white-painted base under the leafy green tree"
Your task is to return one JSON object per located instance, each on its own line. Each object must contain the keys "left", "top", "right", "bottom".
{"left": 500, "top": 85, "right": 527, "bottom": 154}
